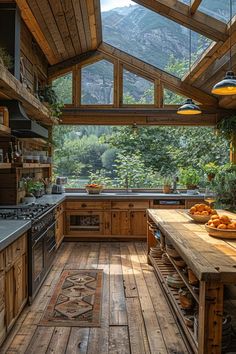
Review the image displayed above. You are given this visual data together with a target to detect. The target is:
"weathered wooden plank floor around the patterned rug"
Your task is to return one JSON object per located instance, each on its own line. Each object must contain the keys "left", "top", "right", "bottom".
{"left": 0, "top": 242, "right": 189, "bottom": 354}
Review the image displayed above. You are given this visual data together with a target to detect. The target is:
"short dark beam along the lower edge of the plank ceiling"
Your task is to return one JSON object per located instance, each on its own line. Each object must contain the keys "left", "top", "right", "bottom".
{"left": 48, "top": 50, "right": 99, "bottom": 79}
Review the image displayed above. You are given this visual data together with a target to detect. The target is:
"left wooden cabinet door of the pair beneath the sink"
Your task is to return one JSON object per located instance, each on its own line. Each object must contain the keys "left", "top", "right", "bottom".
{"left": 111, "top": 210, "right": 130, "bottom": 236}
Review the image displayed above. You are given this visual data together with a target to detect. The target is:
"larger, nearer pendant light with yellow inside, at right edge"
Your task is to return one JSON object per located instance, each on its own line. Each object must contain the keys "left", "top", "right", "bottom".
{"left": 211, "top": 0, "right": 236, "bottom": 96}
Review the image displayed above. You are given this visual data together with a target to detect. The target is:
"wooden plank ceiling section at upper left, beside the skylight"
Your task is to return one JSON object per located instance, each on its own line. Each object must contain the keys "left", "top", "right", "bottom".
{"left": 16, "top": 0, "right": 102, "bottom": 64}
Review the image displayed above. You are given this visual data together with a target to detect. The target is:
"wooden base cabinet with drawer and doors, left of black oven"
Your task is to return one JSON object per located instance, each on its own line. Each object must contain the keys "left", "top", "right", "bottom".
{"left": 4, "top": 234, "right": 28, "bottom": 331}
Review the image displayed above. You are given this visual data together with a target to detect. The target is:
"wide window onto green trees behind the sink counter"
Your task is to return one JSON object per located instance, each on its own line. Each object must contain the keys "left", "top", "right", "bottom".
{"left": 53, "top": 126, "right": 229, "bottom": 189}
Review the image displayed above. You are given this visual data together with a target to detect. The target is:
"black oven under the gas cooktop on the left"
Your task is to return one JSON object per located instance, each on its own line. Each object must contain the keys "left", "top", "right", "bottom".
{"left": 28, "top": 208, "right": 56, "bottom": 303}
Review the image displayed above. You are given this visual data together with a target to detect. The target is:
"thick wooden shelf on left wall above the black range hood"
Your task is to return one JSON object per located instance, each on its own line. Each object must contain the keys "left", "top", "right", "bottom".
{"left": 0, "top": 64, "right": 56, "bottom": 125}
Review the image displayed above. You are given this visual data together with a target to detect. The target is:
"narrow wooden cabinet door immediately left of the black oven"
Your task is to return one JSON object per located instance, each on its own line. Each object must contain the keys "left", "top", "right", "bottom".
{"left": 14, "top": 254, "right": 27, "bottom": 317}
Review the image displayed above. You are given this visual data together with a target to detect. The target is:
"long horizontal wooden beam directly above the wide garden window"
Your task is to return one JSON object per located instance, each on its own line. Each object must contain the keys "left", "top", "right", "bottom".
{"left": 61, "top": 106, "right": 218, "bottom": 126}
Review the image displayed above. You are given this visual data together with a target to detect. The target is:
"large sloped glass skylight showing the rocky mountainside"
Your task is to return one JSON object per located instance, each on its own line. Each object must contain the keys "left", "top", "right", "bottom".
{"left": 101, "top": 0, "right": 212, "bottom": 77}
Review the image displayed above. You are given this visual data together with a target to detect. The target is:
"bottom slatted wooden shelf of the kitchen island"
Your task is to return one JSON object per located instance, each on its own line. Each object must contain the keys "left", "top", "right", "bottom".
{"left": 148, "top": 255, "right": 198, "bottom": 353}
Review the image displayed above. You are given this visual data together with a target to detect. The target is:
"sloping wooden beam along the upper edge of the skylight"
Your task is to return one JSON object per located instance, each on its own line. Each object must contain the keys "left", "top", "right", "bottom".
{"left": 134, "top": 0, "right": 228, "bottom": 42}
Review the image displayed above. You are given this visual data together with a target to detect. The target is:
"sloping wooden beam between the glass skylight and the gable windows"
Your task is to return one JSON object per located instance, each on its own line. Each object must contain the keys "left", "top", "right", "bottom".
{"left": 98, "top": 42, "right": 218, "bottom": 106}
